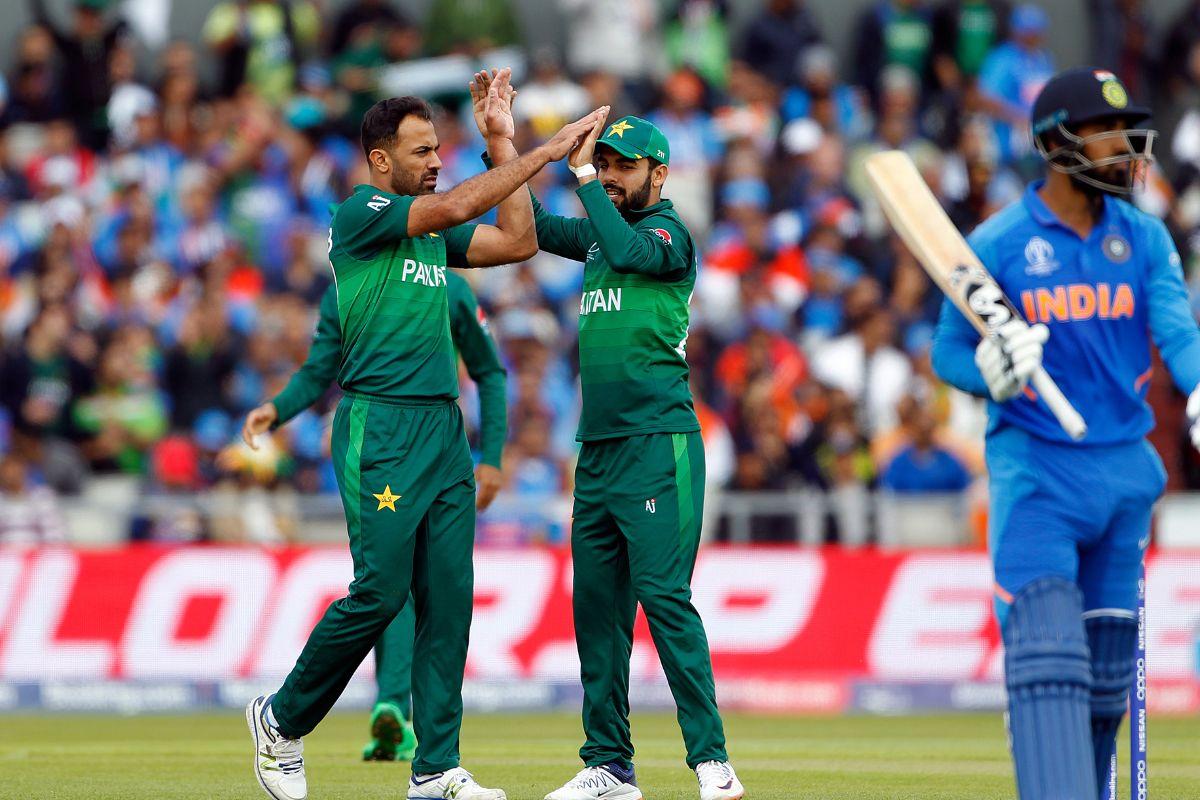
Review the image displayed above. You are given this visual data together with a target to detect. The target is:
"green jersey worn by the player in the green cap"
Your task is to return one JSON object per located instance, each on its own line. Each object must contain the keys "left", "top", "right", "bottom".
{"left": 534, "top": 181, "right": 700, "bottom": 441}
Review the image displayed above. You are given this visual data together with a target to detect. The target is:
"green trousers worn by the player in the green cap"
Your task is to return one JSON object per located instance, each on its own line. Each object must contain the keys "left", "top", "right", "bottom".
{"left": 571, "top": 432, "right": 728, "bottom": 768}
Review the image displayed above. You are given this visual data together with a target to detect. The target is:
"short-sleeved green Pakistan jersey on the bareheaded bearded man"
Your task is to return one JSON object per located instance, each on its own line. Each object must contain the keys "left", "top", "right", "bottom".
{"left": 329, "top": 185, "right": 475, "bottom": 402}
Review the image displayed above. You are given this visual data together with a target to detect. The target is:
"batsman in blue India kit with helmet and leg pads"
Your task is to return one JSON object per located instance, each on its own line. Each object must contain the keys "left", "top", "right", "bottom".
{"left": 934, "top": 68, "right": 1200, "bottom": 800}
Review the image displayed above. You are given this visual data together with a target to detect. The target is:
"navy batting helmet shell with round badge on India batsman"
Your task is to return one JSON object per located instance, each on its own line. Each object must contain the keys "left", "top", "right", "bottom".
{"left": 1031, "top": 67, "right": 1151, "bottom": 136}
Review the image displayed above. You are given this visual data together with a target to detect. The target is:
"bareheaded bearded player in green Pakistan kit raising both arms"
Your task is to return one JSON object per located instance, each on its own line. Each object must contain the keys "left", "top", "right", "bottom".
{"left": 246, "top": 70, "right": 599, "bottom": 800}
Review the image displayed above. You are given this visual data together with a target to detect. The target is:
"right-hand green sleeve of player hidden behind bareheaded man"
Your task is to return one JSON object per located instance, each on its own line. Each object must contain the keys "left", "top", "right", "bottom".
{"left": 446, "top": 276, "right": 508, "bottom": 469}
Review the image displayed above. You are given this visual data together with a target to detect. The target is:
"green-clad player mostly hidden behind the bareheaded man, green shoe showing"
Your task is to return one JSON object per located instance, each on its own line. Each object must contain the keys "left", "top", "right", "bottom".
{"left": 241, "top": 271, "right": 508, "bottom": 762}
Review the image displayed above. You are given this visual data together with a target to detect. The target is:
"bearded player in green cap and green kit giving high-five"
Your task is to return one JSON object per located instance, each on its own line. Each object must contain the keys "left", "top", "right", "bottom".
{"left": 473, "top": 74, "right": 744, "bottom": 800}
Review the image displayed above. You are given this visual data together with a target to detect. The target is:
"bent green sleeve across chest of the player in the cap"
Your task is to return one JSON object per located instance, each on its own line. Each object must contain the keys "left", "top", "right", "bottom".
{"left": 576, "top": 181, "right": 691, "bottom": 281}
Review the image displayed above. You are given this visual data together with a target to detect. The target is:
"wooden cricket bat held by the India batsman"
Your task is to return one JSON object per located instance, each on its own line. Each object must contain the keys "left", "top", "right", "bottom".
{"left": 866, "top": 150, "right": 1087, "bottom": 441}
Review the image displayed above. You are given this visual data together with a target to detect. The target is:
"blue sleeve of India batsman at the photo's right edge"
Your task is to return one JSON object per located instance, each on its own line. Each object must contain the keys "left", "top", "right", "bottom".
{"left": 1146, "top": 219, "right": 1200, "bottom": 395}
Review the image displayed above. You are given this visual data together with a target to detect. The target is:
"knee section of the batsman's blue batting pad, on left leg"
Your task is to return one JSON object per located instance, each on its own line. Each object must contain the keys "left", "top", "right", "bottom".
{"left": 1003, "top": 577, "right": 1092, "bottom": 696}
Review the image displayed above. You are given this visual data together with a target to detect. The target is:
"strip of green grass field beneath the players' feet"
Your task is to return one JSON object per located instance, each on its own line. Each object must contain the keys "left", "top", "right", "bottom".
{"left": 0, "top": 711, "right": 1200, "bottom": 800}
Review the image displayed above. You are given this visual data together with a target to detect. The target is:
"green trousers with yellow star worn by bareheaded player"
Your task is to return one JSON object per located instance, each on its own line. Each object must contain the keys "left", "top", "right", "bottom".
{"left": 271, "top": 395, "right": 475, "bottom": 774}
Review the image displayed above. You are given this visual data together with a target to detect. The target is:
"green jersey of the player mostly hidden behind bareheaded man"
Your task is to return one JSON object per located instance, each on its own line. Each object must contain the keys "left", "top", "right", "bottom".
{"left": 271, "top": 272, "right": 508, "bottom": 468}
